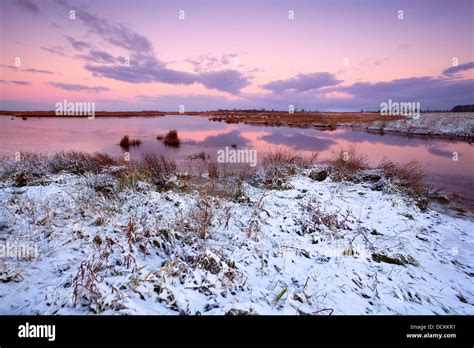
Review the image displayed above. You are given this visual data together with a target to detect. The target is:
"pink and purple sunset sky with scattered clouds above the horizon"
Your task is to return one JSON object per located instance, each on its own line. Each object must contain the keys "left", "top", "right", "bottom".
{"left": 0, "top": 0, "right": 474, "bottom": 110}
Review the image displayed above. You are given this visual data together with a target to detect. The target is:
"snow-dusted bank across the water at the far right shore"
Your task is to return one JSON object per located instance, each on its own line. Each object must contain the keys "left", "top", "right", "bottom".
{"left": 356, "top": 112, "right": 474, "bottom": 138}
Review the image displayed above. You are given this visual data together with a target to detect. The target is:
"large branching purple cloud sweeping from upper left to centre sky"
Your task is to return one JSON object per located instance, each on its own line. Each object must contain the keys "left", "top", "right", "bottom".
{"left": 60, "top": 8, "right": 250, "bottom": 94}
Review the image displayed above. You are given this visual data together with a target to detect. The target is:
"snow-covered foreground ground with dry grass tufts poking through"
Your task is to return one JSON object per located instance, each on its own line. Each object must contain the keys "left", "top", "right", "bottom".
{"left": 0, "top": 163, "right": 474, "bottom": 315}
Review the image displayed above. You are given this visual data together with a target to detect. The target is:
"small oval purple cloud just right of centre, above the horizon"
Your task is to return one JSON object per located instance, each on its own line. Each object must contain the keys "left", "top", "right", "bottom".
{"left": 262, "top": 72, "right": 342, "bottom": 93}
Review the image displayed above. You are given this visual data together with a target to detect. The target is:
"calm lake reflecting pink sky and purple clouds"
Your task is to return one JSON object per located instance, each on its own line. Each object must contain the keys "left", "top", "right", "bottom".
{"left": 0, "top": 115, "right": 474, "bottom": 205}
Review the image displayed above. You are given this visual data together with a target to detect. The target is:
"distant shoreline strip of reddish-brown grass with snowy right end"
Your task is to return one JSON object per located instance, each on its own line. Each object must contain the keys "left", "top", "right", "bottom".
{"left": 0, "top": 110, "right": 474, "bottom": 142}
